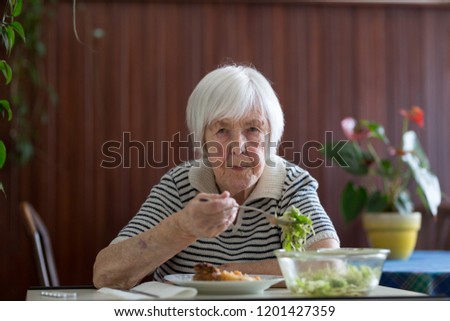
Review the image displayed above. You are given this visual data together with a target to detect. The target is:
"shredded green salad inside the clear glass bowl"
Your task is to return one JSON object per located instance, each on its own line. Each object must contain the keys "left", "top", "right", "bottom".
{"left": 291, "top": 265, "right": 381, "bottom": 296}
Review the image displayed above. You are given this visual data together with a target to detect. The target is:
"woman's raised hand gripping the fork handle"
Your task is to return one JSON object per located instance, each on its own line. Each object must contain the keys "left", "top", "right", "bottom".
{"left": 177, "top": 192, "right": 238, "bottom": 238}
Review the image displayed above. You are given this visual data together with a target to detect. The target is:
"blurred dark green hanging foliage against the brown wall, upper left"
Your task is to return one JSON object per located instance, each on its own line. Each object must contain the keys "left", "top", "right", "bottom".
{"left": 9, "top": 0, "right": 58, "bottom": 165}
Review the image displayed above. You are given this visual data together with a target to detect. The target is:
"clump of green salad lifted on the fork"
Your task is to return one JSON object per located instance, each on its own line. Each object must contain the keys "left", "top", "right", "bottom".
{"left": 281, "top": 206, "right": 314, "bottom": 251}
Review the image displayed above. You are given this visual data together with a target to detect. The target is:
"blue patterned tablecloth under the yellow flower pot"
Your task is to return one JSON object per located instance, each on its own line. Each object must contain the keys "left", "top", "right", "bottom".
{"left": 380, "top": 251, "right": 450, "bottom": 297}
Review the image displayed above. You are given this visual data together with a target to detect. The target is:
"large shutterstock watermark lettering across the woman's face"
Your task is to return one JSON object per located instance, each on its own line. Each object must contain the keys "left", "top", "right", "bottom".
{"left": 100, "top": 131, "right": 348, "bottom": 169}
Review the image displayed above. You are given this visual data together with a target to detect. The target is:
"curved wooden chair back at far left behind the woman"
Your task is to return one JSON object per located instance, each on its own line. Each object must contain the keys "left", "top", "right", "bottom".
{"left": 19, "top": 201, "right": 59, "bottom": 287}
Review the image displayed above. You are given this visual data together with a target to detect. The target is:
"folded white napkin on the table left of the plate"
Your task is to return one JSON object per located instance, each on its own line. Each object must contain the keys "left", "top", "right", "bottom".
{"left": 97, "top": 281, "right": 197, "bottom": 300}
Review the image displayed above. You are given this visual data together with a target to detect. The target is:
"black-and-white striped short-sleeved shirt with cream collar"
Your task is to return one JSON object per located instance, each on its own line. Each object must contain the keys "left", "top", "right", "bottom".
{"left": 112, "top": 156, "right": 339, "bottom": 281}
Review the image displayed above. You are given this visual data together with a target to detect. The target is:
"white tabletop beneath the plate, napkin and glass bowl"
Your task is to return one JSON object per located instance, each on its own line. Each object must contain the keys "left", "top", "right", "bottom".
{"left": 26, "top": 286, "right": 427, "bottom": 301}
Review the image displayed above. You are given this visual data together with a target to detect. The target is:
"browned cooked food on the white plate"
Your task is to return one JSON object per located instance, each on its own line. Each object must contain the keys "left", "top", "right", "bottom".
{"left": 193, "top": 263, "right": 261, "bottom": 281}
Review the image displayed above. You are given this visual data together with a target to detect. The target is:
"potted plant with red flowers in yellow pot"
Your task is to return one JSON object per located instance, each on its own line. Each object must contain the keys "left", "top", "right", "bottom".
{"left": 324, "top": 106, "right": 441, "bottom": 259}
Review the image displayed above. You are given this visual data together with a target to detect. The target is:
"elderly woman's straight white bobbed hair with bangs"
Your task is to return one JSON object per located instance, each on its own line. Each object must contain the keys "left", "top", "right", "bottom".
{"left": 186, "top": 65, "right": 284, "bottom": 153}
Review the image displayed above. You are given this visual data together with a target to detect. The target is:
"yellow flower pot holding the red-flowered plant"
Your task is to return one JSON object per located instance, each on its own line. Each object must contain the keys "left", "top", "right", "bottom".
{"left": 362, "top": 212, "right": 422, "bottom": 260}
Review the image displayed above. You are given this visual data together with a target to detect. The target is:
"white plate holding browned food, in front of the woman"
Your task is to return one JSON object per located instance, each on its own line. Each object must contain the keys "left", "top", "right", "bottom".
{"left": 164, "top": 274, "right": 284, "bottom": 294}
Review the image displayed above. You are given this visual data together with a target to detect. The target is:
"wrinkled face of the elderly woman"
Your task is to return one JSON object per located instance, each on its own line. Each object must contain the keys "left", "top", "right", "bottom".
{"left": 205, "top": 111, "right": 270, "bottom": 199}
